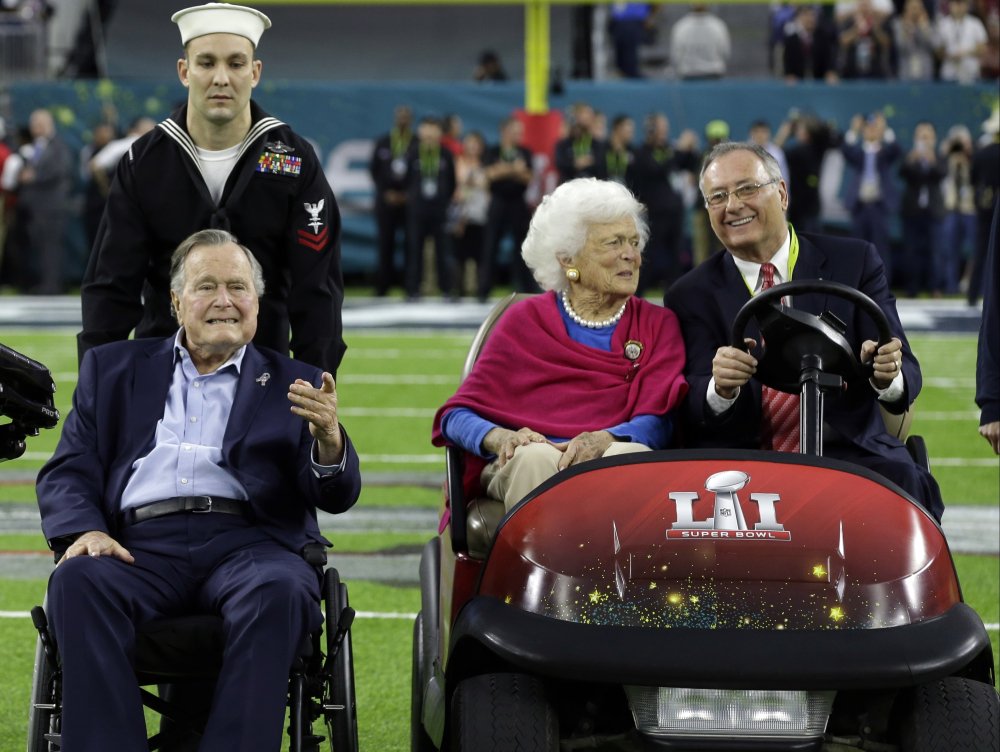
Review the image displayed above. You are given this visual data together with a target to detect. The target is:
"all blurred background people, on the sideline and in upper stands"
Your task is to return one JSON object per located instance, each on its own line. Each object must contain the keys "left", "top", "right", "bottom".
{"left": 0, "top": 0, "right": 1000, "bottom": 304}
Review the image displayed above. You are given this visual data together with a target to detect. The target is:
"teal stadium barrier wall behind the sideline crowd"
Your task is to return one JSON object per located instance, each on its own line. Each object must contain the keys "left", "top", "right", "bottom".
{"left": 7, "top": 77, "right": 997, "bottom": 275}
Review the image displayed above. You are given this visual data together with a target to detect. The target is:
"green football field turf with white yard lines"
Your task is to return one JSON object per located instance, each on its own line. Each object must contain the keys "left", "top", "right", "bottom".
{"left": 0, "top": 330, "right": 1000, "bottom": 752}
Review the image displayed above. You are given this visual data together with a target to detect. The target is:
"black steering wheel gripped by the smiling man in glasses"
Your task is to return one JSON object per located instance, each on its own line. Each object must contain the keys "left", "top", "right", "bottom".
{"left": 730, "top": 279, "right": 892, "bottom": 394}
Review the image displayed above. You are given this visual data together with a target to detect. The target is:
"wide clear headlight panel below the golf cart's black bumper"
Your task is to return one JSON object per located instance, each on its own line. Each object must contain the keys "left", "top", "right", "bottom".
{"left": 625, "top": 686, "right": 836, "bottom": 739}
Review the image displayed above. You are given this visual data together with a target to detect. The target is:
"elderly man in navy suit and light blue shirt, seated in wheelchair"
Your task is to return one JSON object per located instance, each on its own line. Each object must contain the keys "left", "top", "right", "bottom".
{"left": 26, "top": 230, "right": 360, "bottom": 752}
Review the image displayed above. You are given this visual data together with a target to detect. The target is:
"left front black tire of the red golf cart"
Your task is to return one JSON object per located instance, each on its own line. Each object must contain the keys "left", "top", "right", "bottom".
{"left": 450, "top": 674, "right": 559, "bottom": 752}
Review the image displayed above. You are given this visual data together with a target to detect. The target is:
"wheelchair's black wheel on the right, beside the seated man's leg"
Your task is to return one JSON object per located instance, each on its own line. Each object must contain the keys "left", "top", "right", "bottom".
{"left": 324, "top": 569, "right": 358, "bottom": 752}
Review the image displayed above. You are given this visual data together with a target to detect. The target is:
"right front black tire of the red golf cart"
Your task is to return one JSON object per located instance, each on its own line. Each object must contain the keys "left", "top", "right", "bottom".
{"left": 899, "top": 677, "right": 1000, "bottom": 752}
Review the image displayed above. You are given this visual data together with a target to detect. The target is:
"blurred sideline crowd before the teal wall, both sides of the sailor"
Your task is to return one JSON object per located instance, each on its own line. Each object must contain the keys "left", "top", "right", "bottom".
{"left": 0, "top": 97, "right": 1000, "bottom": 304}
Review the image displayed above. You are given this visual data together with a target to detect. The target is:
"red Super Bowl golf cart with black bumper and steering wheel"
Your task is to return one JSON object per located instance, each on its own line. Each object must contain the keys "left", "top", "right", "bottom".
{"left": 411, "top": 281, "right": 1000, "bottom": 752}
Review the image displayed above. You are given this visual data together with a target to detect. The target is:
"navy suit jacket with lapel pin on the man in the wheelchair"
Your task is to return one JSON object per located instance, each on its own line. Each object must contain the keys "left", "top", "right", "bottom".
{"left": 37, "top": 337, "right": 361, "bottom": 551}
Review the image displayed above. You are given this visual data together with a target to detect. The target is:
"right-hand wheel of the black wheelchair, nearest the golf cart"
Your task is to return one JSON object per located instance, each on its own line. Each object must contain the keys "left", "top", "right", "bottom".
{"left": 323, "top": 568, "right": 358, "bottom": 752}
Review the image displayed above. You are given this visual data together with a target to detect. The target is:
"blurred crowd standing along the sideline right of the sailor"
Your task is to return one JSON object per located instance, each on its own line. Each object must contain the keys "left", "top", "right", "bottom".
{"left": 371, "top": 102, "right": 1000, "bottom": 304}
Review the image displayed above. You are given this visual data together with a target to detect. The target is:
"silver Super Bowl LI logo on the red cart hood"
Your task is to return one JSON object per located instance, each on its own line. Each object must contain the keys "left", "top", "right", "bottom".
{"left": 667, "top": 470, "right": 792, "bottom": 541}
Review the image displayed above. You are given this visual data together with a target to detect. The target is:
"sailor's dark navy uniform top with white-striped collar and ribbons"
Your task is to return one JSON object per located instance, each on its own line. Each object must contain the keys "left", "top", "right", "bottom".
{"left": 78, "top": 102, "right": 346, "bottom": 374}
